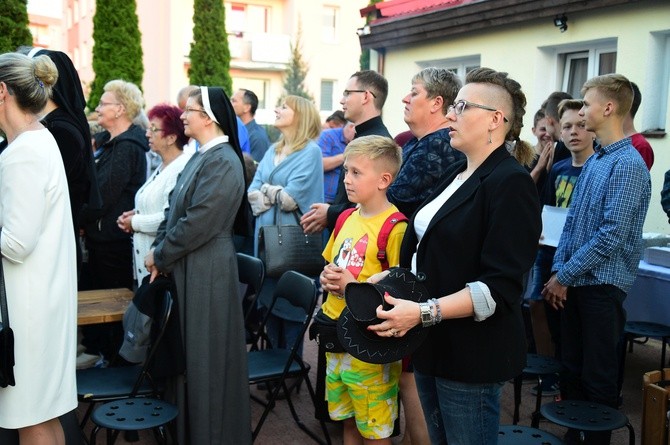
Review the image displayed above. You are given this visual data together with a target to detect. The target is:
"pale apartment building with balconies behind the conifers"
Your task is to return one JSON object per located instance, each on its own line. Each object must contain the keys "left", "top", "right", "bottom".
{"left": 36, "top": 0, "right": 368, "bottom": 123}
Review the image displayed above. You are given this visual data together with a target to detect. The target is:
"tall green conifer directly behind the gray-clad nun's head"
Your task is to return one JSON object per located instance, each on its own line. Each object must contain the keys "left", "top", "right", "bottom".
{"left": 188, "top": 0, "right": 233, "bottom": 95}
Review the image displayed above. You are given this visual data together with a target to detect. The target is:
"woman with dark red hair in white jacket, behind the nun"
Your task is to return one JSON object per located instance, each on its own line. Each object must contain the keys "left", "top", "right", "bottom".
{"left": 117, "top": 104, "right": 190, "bottom": 286}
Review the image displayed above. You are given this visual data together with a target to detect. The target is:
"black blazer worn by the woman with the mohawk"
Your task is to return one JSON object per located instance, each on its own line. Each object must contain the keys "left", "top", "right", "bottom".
{"left": 400, "top": 146, "right": 541, "bottom": 383}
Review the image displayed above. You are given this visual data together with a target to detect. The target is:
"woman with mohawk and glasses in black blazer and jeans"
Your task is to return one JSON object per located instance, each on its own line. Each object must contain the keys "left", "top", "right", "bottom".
{"left": 370, "top": 68, "right": 541, "bottom": 445}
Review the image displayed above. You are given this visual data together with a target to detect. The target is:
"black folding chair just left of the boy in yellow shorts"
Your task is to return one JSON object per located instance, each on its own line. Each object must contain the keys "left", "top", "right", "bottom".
{"left": 248, "top": 271, "right": 330, "bottom": 444}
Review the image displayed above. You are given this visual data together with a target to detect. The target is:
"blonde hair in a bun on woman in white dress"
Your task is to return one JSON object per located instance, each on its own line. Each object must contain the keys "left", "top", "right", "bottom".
{"left": 0, "top": 53, "right": 58, "bottom": 114}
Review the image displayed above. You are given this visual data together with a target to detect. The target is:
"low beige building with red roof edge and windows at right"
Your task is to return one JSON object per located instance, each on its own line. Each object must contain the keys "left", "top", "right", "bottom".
{"left": 360, "top": 0, "right": 670, "bottom": 233}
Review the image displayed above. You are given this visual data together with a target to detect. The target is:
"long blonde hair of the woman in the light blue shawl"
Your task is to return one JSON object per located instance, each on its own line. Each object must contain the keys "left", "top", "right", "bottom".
{"left": 275, "top": 96, "right": 321, "bottom": 154}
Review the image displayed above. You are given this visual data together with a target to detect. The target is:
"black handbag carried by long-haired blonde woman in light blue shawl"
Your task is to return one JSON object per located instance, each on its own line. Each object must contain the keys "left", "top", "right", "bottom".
{"left": 258, "top": 197, "right": 325, "bottom": 278}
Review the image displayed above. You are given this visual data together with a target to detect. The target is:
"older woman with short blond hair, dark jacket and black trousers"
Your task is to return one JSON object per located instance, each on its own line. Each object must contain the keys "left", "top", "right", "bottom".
{"left": 80, "top": 80, "right": 149, "bottom": 359}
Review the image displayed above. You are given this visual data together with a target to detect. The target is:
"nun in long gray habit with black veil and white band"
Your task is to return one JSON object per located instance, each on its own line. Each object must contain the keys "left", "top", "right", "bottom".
{"left": 145, "top": 87, "right": 251, "bottom": 445}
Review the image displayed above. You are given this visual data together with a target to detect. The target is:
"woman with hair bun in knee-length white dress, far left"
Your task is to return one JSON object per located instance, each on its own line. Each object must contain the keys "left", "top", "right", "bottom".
{"left": 0, "top": 53, "right": 77, "bottom": 445}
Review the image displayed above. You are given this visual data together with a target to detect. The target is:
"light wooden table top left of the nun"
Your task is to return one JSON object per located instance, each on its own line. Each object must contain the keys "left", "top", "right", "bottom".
{"left": 77, "top": 289, "right": 134, "bottom": 326}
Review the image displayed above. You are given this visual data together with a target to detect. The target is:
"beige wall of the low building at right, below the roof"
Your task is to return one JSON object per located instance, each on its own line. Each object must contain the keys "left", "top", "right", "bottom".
{"left": 384, "top": 3, "right": 670, "bottom": 233}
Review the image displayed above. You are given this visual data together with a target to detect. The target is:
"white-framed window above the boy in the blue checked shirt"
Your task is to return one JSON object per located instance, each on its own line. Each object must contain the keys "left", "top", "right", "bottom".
{"left": 560, "top": 45, "right": 616, "bottom": 97}
